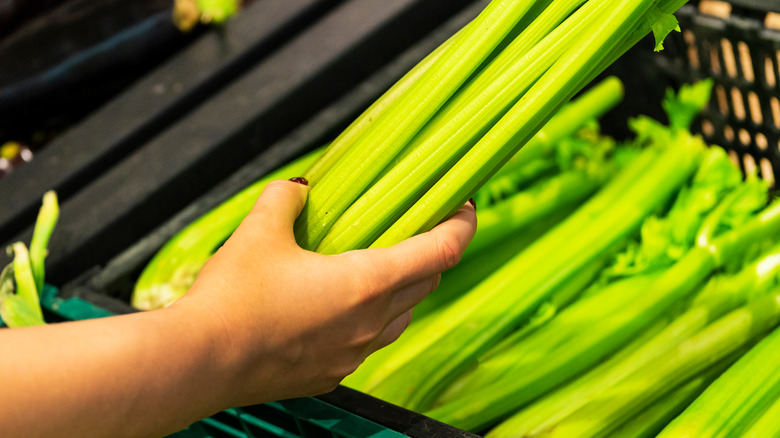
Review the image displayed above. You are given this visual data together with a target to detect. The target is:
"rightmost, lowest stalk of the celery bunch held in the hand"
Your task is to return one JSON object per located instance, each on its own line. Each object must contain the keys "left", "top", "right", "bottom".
{"left": 371, "top": 0, "right": 654, "bottom": 247}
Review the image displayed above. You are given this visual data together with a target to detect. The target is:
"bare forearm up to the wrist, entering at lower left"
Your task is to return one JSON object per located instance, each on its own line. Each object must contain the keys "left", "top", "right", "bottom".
{"left": 0, "top": 309, "right": 230, "bottom": 437}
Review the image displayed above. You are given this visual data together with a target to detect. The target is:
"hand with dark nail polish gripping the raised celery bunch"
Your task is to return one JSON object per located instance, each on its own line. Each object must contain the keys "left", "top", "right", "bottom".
{"left": 171, "top": 177, "right": 476, "bottom": 406}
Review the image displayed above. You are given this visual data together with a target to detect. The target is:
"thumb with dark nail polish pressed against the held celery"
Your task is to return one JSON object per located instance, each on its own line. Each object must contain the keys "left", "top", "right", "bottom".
{"left": 242, "top": 180, "right": 310, "bottom": 242}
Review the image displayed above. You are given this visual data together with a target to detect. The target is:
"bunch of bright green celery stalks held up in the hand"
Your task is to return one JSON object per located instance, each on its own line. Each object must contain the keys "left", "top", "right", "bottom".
{"left": 133, "top": 0, "right": 685, "bottom": 309}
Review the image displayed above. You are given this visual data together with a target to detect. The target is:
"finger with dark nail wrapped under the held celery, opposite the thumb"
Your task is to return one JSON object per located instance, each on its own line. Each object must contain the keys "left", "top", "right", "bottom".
{"left": 369, "top": 203, "right": 477, "bottom": 287}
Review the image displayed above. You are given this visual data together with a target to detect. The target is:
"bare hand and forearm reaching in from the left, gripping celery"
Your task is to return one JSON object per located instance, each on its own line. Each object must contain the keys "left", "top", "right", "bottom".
{"left": 0, "top": 181, "right": 476, "bottom": 437}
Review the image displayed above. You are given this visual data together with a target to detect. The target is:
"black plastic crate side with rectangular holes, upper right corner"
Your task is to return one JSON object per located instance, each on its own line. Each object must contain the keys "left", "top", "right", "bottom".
{"left": 658, "top": 0, "right": 780, "bottom": 187}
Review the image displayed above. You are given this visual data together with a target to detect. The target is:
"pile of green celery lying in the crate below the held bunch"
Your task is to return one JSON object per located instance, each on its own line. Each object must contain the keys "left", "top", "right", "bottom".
{"left": 346, "top": 83, "right": 780, "bottom": 437}
